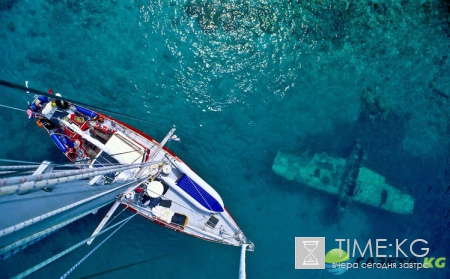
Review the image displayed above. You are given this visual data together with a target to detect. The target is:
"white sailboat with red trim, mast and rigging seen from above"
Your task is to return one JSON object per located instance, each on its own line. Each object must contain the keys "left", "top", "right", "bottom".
{"left": 0, "top": 81, "right": 254, "bottom": 278}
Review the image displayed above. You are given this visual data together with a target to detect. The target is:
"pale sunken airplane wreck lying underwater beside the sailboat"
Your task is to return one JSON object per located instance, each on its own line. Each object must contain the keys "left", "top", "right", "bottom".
{"left": 272, "top": 143, "right": 414, "bottom": 214}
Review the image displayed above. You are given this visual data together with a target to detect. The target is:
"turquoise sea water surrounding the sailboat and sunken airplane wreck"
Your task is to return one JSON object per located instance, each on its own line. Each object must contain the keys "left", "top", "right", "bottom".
{"left": 0, "top": 0, "right": 450, "bottom": 278}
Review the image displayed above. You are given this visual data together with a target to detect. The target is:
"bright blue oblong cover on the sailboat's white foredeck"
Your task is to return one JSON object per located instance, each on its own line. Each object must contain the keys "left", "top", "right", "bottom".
{"left": 176, "top": 173, "right": 223, "bottom": 212}
